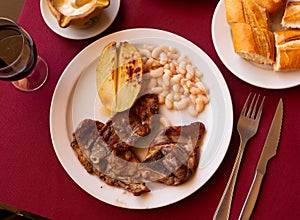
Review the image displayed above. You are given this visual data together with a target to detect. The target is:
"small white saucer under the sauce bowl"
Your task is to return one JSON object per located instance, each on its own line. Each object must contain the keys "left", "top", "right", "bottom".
{"left": 40, "top": 0, "right": 121, "bottom": 40}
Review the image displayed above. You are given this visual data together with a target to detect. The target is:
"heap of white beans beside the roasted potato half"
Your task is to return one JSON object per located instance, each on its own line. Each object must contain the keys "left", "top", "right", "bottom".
{"left": 140, "top": 45, "right": 209, "bottom": 117}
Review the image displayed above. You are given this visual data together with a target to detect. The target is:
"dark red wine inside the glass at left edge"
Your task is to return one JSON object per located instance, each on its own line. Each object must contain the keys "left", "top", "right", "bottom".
{"left": 0, "top": 25, "right": 37, "bottom": 81}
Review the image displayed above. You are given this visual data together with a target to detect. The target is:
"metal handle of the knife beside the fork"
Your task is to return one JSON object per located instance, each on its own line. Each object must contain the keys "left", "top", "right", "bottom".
{"left": 239, "top": 171, "right": 264, "bottom": 220}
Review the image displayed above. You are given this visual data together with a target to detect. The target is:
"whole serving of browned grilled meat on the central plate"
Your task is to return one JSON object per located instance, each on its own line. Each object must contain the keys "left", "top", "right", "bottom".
{"left": 71, "top": 94, "right": 205, "bottom": 196}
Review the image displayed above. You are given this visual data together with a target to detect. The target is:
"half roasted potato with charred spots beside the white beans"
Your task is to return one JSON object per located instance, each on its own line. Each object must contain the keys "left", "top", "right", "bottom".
{"left": 96, "top": 42, "right": 143, "bottom": 112}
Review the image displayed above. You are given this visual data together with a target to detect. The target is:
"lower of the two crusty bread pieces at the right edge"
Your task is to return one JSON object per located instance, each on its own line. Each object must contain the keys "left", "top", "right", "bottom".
{"left": 273, "top": 30, "right": 300, "bottom": 71}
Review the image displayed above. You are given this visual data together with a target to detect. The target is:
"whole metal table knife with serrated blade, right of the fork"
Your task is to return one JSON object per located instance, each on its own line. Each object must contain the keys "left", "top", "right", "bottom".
{"left": 239, "top": 98, "right": 283, "bottom": 220}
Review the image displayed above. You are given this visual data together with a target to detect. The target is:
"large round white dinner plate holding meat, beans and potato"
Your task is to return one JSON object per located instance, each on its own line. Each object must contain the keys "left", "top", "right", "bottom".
{"left": 50, "top": 28, "right": 233, "bottom": 209}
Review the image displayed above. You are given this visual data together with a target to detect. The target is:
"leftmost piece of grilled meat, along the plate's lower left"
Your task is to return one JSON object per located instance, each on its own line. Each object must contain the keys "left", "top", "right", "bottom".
{"left": 71, "top": 119, "right": 150, "bottom": 195}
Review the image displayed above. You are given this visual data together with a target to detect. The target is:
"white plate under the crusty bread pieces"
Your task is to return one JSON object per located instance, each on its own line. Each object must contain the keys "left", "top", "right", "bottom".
{"left": 212, "top": 0, "right": 300, "bottom": 89}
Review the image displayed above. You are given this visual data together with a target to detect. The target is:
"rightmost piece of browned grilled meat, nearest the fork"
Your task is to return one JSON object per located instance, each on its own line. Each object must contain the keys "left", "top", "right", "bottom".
{"left": 139, "top": 122, "right": 205, "bottom": 185}
